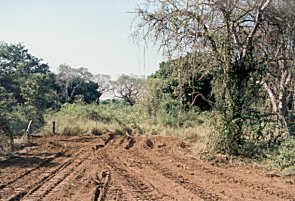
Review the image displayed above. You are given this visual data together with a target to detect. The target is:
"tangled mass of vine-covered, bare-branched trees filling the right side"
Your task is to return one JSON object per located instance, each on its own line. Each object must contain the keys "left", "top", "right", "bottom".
{"left": 134, "top": 0, "right": 295, "bottom": 155}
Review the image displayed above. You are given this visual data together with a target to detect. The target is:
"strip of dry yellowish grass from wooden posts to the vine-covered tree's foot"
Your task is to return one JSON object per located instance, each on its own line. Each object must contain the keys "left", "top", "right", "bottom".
{"left": 43, "top": 105, "right": 214, "bottom": 154}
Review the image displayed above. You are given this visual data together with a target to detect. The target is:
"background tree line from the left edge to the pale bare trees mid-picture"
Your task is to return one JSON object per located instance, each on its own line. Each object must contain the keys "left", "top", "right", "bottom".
{"left": 0, "top": 42, "right": 145, "bottom": 150}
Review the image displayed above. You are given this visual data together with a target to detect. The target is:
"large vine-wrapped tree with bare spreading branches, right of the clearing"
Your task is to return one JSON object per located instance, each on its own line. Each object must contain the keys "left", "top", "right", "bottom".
{"left": 134, "top": 0, "right": 294, "bottom": 154}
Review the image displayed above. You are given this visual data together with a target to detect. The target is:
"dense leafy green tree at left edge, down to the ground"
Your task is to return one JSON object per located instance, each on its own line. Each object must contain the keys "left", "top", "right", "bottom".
{"left": 0, "top": 42, "right": 56, "bottom": 150}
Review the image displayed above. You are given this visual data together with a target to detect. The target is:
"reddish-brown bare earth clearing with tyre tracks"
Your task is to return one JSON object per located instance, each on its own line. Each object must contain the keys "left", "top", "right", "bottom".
{"left": 0, "top": 133, "right": 295, "bottom": 201}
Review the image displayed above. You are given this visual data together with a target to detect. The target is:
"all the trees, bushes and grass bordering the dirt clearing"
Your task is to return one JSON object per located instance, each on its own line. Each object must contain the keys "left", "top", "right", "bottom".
{"left": 0, "top": 0, "right": 295, "bottom": 175}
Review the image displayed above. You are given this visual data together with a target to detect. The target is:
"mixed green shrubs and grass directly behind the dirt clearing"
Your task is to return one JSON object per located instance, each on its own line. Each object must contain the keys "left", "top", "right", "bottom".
{"left": 44, "top": 102, "right": 209, "bottom": 140}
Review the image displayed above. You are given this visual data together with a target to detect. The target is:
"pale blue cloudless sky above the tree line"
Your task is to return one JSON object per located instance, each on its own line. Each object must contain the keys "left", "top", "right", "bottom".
{"left": 0, "top": 0, "right": 163, "bottom": 78}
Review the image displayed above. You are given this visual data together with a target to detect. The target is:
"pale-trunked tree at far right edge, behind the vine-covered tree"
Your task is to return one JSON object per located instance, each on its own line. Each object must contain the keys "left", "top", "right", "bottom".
{"left": 260, "top": 1, "right": 295, "bottom": 137}
